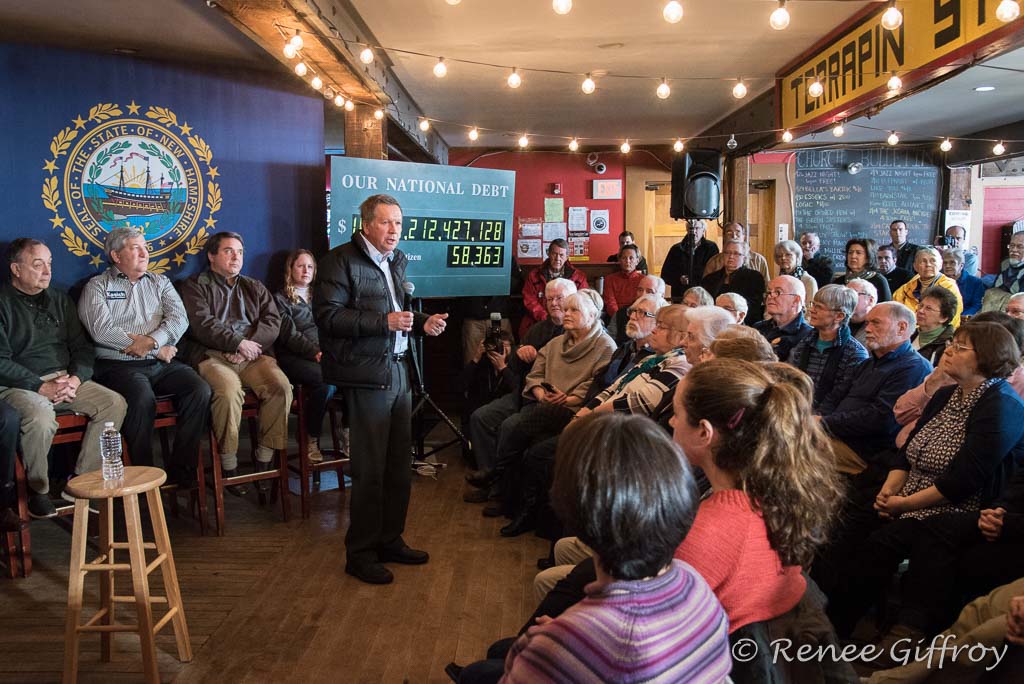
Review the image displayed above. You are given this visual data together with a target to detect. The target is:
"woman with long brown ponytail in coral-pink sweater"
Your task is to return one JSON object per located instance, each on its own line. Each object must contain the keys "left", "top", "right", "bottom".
{"left": 673, "top": 359, "right": 842, "bottom": 633}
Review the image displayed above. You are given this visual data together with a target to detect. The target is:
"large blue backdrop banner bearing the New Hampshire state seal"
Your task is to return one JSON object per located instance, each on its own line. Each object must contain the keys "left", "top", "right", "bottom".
{"left": 0, "top": 45, "right": 325, "bottom": 287}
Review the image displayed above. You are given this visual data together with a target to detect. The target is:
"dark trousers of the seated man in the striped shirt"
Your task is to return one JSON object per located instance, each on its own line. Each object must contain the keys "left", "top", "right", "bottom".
{"left": 94, "top": 359, "right": 211, "bottom": 476}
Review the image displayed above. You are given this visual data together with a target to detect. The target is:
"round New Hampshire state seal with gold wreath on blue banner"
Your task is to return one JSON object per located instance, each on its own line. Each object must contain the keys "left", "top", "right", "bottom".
{"left": 41, "top": 100, "right": 222, "bottom": 273}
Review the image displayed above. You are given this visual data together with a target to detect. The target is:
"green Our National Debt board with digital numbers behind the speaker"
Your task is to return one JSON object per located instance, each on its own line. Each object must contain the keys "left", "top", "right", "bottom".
{"left": 330, "top": 157, "right": 515, "bottom": 297}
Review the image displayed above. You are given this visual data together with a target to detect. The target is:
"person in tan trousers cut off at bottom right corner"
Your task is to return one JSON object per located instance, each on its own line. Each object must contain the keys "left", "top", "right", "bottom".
{"left": 861, "top": 578, "right": 1024, "bottom": 684}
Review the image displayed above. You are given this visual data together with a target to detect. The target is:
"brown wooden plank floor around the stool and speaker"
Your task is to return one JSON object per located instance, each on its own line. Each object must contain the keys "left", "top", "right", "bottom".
{"left": 0, "top": 436, "right": 548, "bottom": 683}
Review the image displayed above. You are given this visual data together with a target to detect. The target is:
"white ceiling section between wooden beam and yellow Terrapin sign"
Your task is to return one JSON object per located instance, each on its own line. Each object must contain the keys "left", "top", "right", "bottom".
{"left": 351, "top": 0, "right": 867, "bottom": 146}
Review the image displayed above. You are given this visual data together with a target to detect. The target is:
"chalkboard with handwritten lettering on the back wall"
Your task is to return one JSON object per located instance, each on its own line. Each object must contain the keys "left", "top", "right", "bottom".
{"left": 795, "top": 148, "right": 941, "bottom": 270}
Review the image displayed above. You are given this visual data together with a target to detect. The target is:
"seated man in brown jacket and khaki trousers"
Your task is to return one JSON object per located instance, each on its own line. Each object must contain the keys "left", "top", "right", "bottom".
{"left": 181, "top": 231, "right": 292, "bottom": 489}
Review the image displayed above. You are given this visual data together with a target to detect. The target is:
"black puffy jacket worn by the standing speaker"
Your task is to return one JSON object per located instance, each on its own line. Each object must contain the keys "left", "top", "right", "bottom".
{"left": 313, "top": 238, "right": 427, "bottom": 389}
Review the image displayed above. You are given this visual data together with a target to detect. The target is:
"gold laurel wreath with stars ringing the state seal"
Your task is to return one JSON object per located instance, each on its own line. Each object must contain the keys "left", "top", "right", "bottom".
{"left": 40, "top": 100, "right": 222, "bottom": 274}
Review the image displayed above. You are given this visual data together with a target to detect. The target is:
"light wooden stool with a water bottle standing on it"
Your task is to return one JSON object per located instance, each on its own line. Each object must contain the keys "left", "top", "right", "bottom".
{"left": 63, "top": 466, "right": 191, "bottom": 682}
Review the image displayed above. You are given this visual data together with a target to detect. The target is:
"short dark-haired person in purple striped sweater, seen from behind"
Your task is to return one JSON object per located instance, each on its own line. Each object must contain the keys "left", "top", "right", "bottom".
{"left": 489, "top": 416, "right": 737, "bottom": 684}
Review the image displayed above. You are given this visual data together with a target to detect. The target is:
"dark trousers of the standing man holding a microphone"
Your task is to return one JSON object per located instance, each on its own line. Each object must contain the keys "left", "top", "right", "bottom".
{"left": 342, "top": 362, "right": 413, "bottom": 563}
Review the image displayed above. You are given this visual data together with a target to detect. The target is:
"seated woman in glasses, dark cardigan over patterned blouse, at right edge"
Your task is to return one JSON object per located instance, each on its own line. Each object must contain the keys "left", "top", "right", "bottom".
{"left": 829, "top": 323, "right": 1024, "bottom": 637}
